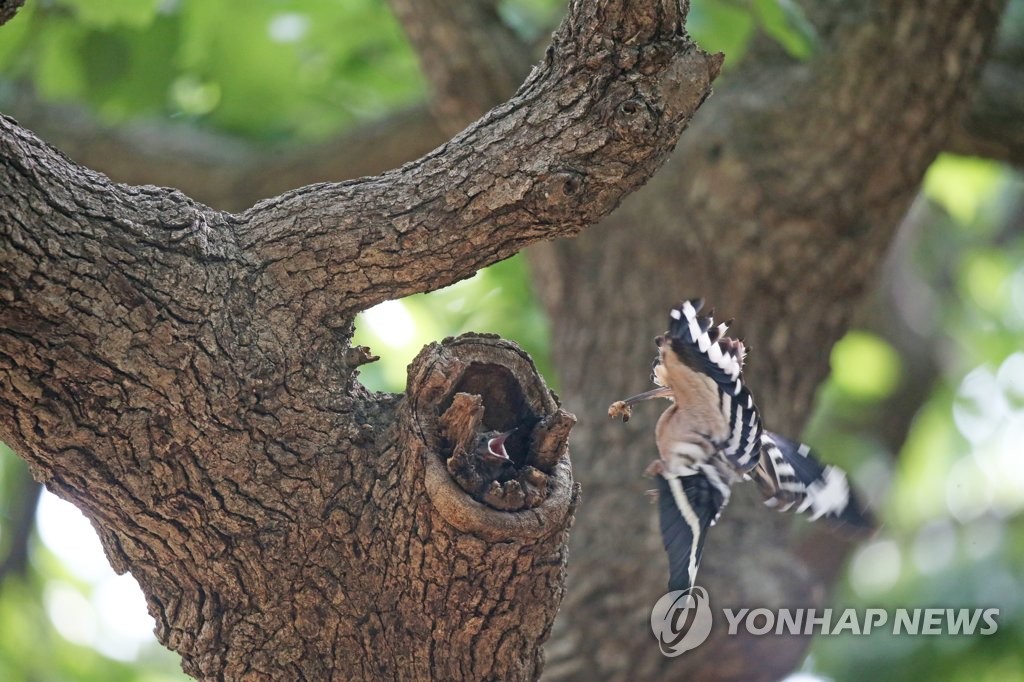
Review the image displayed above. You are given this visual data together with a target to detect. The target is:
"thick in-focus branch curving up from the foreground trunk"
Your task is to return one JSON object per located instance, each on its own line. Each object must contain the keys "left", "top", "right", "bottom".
{"left": 241, "top": 0, "right": 721, "bottom": 323}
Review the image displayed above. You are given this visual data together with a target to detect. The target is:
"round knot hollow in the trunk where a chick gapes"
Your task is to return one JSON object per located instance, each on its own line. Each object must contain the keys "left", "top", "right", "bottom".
{"left": 408, "top": 335, "right": 575, "bottom": 539}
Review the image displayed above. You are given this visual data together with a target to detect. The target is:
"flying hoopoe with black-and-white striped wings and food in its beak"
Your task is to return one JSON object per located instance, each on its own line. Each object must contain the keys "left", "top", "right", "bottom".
{"left": 608, "top": 299, "right": 873, "bottom": 590}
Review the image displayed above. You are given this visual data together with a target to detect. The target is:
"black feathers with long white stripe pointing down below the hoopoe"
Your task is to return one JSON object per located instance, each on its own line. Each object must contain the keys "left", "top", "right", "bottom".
{"left": 654, "top": 472, "right": 728, "bottom": 590}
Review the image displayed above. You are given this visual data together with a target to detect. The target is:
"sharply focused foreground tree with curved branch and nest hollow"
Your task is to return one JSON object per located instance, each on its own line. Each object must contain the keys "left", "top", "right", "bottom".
{"left": 0, "top": 0, "right": 721, "bottom": 680}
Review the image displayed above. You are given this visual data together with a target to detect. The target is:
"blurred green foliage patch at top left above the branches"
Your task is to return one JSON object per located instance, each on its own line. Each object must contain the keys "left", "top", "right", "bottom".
{"left": 0, "top": 0, "right": 425, "bottom": 140}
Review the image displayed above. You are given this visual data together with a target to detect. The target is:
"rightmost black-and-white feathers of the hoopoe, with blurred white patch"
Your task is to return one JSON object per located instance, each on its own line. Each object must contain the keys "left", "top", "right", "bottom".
{"left": 751, "top": 431, "right": 876, "bottom": 529}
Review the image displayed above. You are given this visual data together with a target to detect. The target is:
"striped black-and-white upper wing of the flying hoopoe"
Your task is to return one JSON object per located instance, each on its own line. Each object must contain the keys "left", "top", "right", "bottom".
{"left": 655, "top": 299, "right": 762, "bottom": 472}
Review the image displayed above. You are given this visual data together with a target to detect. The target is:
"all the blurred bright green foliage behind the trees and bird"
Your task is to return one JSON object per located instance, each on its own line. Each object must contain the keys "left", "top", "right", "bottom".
{"left": 0, "top": 0, "right": 1024, "bottom": 682}
